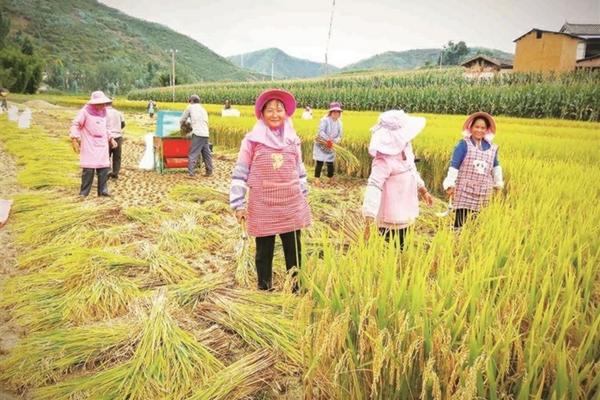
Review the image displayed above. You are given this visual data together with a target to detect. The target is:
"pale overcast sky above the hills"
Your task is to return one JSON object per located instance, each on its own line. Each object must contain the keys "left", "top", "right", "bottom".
{"left": 100, "top": 0, "right": 600, "bottom": 67}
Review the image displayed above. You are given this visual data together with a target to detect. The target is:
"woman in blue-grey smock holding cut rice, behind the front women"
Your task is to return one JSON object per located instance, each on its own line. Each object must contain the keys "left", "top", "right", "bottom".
{"left": 313, "top": 102, "right": 342, "bottom": 186}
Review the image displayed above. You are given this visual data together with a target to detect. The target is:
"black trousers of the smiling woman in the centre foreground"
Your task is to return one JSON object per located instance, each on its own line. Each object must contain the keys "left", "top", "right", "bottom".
{"left": 255, "top": 230, "right": 302, "bottom": 291}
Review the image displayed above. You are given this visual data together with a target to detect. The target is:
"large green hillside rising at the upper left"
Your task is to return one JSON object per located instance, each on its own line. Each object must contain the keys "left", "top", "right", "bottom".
{"left": 0, "top": 0, "right": 261, "bottom": 92}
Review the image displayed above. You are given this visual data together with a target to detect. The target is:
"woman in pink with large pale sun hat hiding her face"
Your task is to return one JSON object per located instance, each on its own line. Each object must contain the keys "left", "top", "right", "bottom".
{"left": 362, "top": 110, "right": 433, "bottom": 249}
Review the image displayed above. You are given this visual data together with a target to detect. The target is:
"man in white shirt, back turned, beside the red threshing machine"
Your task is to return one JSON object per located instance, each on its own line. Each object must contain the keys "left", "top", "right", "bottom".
{"left": 180, "top": 94, "right": 213, "bottom": 178}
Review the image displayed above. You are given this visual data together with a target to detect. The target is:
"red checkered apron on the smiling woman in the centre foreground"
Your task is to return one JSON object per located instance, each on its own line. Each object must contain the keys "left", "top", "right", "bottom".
{"left": 248, "top": 143, "right": 311, "bottom": 237}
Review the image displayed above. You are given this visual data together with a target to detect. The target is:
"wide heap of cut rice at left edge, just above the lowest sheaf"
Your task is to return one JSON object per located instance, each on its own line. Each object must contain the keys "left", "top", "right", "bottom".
{"left": 0, "top": 248, "right": 148, "bottom": 331}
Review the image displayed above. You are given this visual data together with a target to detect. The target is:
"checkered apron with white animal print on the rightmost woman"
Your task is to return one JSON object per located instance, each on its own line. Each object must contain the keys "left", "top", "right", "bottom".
{"left": 452, "top": 138, "right": 498, "bottom": 211}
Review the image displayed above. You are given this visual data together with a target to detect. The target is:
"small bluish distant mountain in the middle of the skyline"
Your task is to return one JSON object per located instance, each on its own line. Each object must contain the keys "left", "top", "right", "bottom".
{"left": 227, "top": 48, "right": 339, "bottom": 79}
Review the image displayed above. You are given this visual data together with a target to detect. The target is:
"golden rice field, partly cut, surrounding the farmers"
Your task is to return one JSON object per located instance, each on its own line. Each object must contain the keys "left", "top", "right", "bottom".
{"left": 0, "top": 97, "right": 600, "bottom": 399}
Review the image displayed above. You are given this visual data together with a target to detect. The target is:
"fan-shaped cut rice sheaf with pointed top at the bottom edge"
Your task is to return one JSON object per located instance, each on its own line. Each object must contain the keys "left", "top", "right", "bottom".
{"left": 34, "top": 291, "right": 224, "bottom": 400}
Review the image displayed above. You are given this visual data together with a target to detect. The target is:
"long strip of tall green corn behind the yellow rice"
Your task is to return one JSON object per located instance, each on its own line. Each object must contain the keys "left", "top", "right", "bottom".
{"left": 128, "top": 70, "right": 600, "bottom": 121}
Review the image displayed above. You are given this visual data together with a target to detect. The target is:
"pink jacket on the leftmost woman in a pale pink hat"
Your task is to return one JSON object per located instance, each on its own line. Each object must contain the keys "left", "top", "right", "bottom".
{"left": 69, "top": 106, "right": 110, "bottom": 168}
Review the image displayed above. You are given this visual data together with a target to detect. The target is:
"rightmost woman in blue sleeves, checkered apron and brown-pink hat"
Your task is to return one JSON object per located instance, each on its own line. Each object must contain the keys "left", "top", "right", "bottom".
{"left": 443, "top": 111, "right": 504, "bottom": 229}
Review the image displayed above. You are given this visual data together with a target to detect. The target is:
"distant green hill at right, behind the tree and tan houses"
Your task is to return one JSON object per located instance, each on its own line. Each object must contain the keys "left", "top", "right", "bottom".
{"left": 342, "top": 47, "right": 514, "bottom": 71}
